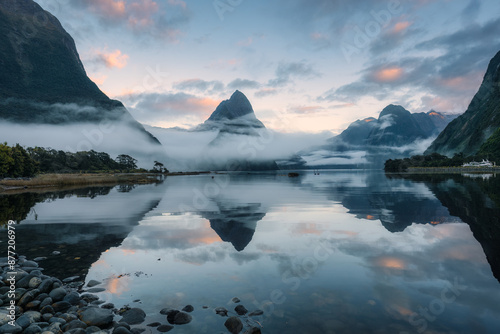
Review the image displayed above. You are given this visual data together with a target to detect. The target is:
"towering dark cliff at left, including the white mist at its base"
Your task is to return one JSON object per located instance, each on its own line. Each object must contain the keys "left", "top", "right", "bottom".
{"left": 0, "top": 0, "right": 168, "bottom": 168}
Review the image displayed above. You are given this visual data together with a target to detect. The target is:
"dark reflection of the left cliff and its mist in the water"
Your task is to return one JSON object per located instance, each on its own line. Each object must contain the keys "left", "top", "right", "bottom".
{"left": 0, "top": 185, "right": 162, "bottom": 278}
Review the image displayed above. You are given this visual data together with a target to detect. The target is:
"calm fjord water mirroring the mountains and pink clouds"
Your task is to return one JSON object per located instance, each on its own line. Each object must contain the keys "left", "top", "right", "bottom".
{"left": 0, "top": 171, "right": 500, "bottom": 333}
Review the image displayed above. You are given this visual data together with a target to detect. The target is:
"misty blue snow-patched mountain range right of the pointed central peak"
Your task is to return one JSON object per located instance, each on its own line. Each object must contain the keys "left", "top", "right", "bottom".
{"left": 278, "top": 104, "right": 456, "bottom": 169}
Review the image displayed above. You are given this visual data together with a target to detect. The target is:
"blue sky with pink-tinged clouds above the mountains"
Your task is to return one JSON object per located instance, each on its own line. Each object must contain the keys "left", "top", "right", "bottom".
{"left": 35, "top": 0, "right": 500, "bottom": 133}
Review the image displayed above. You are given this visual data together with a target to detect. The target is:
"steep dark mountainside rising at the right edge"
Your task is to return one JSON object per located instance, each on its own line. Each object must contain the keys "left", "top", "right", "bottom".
{"left": 425, "top": 52, "right": 500, "bottom": 156}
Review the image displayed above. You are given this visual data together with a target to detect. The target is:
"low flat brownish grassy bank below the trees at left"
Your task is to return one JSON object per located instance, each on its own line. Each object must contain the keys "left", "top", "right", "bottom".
{"left": 0, "top": 173, "right": 164, "bottom": 191}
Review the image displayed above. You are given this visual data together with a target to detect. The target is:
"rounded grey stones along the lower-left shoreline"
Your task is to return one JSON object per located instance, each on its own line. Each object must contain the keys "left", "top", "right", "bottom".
{"left": 0, "top": 256, "right": 263, "bottom": 334}
